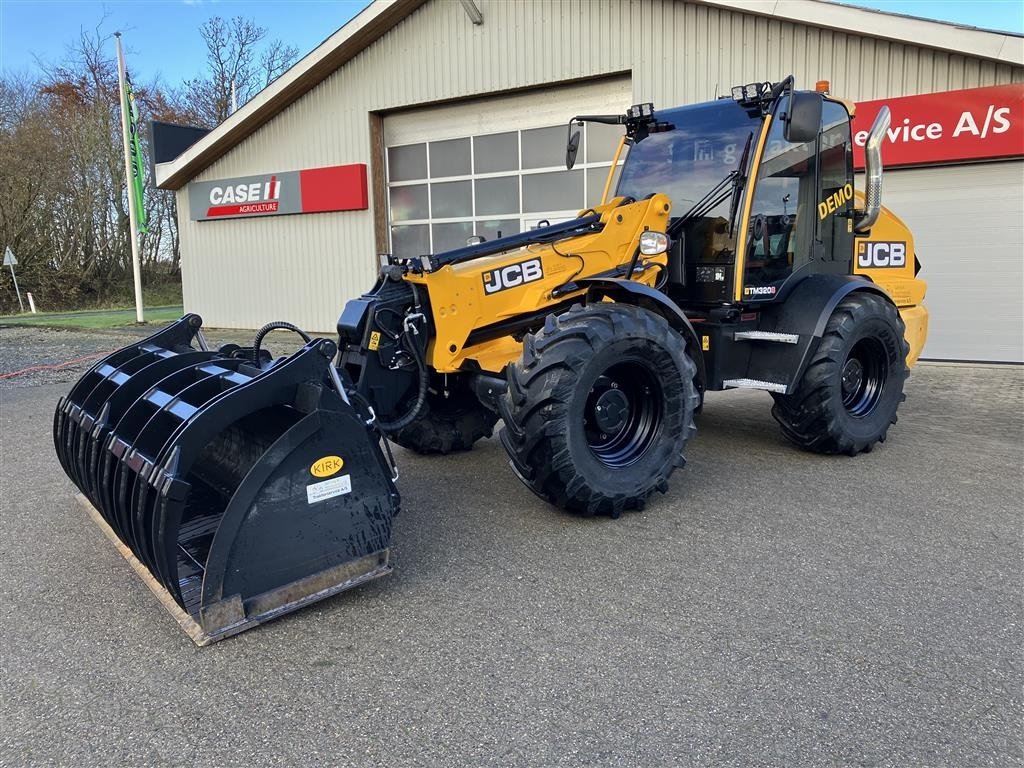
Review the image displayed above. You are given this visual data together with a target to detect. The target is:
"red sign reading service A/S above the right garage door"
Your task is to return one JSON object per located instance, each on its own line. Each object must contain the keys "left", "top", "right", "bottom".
{"left": 853, "top": 83, "right": 1024, "bottom": 169}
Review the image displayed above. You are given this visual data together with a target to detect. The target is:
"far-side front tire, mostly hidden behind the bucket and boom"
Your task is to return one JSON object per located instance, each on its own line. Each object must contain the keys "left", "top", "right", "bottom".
{"left": 388, "top": 390, "right": 498, "bottom": 455}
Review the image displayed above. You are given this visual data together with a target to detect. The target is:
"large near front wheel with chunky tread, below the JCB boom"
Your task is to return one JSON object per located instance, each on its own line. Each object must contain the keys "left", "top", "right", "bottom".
{"left": 499, "top": 302, "right": 697, "bottom": 517}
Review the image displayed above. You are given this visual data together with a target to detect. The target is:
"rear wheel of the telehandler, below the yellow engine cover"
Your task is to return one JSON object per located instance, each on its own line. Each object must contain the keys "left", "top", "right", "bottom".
{"left": 772, "top": 292, "right": 910, "bottom": 456}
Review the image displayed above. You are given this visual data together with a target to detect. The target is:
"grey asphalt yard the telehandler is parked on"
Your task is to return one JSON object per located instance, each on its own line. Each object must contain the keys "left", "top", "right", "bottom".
{"left": 0, "top": 327, "right": 1024, "bottom": 768}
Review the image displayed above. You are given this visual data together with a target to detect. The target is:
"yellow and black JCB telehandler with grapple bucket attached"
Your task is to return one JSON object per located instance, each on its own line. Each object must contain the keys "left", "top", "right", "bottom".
{"left": 54, "top": 77, "right": 928, "bottom": 643}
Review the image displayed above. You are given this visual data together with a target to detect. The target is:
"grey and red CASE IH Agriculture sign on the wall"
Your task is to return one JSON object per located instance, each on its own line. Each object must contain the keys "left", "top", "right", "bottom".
{"left": 188, "top": 163, "right": 368, "bottom": 221}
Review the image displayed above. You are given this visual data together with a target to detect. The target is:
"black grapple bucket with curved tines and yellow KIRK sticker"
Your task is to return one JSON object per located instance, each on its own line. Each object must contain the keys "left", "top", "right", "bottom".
{"left": 53, "top": 314, "right": 398, "bottom": 644}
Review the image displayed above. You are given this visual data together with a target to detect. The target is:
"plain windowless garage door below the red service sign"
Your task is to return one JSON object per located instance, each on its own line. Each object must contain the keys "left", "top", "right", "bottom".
{"left": 883, "top": 161, "right": 1024, "bottom": 362}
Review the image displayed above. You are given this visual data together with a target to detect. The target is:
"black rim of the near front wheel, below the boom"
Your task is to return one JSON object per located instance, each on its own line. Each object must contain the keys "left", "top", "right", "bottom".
{"left": 584, "top": 360, "right": 665, "bottom": 468}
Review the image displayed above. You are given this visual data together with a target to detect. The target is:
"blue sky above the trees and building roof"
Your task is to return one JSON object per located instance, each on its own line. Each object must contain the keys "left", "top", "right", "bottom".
{"left": 0, "top": 0, "right": 1024, "bottom": 82}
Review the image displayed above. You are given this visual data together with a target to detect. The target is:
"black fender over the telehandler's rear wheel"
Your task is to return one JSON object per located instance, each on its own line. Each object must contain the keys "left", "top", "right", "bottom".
{"left": 751, "top": 274, "right": 892, "bottom": 391}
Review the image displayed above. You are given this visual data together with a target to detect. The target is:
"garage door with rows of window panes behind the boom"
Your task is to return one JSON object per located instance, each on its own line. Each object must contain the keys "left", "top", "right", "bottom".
{"left": 384, "top": 78, "right": 632, "bottom": 257}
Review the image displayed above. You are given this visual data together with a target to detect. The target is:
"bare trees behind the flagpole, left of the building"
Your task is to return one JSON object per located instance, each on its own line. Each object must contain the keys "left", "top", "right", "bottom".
{"left": 0, "top": 16, "right": 297, "bottom": 311}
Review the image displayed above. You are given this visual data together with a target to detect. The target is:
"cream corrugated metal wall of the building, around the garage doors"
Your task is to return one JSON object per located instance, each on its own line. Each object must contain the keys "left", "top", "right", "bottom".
{"left": 172, "top": 0, "right": 1024, "bottom": 331}
